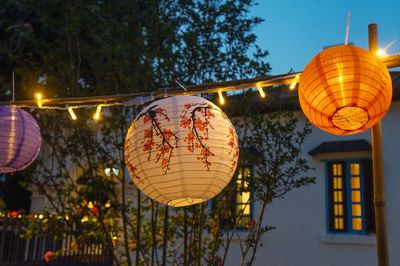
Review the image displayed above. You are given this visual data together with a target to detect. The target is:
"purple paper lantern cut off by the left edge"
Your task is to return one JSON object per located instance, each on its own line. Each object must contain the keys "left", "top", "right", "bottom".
{"left": 0, "top": 106, "right": 41, "bottom": 173}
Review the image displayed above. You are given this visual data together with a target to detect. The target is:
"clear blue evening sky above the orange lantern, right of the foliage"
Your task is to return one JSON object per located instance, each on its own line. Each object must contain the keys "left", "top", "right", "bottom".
{"left": 252, "top": 0, "right": 400, "bottom": 74}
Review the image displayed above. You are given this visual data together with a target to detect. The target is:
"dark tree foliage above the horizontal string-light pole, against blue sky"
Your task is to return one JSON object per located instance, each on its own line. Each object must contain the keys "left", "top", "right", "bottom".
{"left": 0, "top": 0, "right": 270, "bottom": 99}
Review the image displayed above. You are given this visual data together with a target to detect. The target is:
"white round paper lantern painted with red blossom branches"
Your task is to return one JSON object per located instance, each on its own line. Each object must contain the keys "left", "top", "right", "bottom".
{"left": 125, "top": 96, "right": 239, "bottom": 207}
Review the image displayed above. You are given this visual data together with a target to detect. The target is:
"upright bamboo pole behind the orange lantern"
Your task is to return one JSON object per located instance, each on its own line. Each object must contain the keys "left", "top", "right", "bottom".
{"left": 368, "top": 24, "right": 389, "bottom": 266}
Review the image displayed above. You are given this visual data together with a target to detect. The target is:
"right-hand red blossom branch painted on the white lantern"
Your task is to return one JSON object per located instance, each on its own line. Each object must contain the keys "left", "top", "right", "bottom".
{"left": 180, "top": 103, "right": 215, "bottom": 170}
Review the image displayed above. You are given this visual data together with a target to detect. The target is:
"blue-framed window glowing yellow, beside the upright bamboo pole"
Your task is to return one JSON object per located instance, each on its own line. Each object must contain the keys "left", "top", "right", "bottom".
{"left": 327, "top": 160, "right": 375, "bottom": 234}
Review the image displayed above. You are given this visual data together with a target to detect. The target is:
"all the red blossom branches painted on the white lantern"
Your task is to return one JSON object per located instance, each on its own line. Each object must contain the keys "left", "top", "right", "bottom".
{"left": 125, "top": 100, "right": 239, "bottom": 179}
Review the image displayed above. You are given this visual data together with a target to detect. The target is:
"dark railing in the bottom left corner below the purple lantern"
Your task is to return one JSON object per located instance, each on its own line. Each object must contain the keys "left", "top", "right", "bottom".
{"left": 0, "top": 218, "right": 112, "bottom": 266}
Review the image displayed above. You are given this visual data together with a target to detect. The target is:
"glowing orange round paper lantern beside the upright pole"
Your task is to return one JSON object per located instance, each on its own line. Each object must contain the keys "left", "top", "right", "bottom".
{"left": 299, "top": 45, "right": 392, "bottom": 135}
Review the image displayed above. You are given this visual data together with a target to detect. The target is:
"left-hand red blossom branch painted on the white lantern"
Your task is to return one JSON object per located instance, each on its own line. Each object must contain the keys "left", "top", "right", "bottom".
{"left": 140, "top": 105, "right": 179, "bottom": 175}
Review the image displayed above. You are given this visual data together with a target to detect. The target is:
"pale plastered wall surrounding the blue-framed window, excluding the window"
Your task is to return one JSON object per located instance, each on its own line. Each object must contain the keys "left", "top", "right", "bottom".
{"left": 227, "top": 102, "right": 400, "bottom": 266}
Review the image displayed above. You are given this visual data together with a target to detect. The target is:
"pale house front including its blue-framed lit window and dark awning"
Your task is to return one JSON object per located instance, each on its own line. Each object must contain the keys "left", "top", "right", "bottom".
{"left": 227, "top": 74, "right": 400, "bottom": 266}
